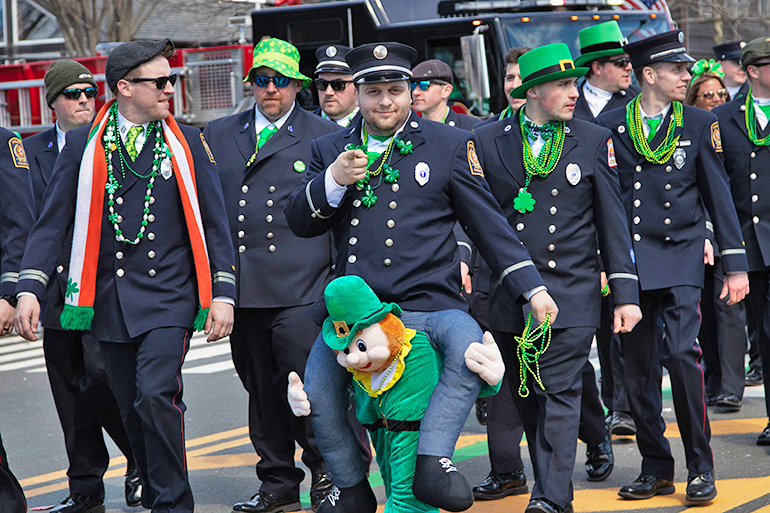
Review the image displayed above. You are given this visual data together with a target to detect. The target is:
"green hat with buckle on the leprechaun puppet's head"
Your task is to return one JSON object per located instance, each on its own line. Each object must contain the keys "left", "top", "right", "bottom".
{"left": 322, "top": 275, "right": 402, "bottom": 351}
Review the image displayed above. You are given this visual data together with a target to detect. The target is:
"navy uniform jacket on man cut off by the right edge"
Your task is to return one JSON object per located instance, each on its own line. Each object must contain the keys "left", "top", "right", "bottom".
{"left": 712, "top": 98, "right": 770, "bottom": 271}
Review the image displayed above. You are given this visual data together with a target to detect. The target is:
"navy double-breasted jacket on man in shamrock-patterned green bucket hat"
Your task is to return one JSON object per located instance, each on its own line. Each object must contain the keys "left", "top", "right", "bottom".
{"left": 204, "top": 104, "right": 340, "bottom": 308}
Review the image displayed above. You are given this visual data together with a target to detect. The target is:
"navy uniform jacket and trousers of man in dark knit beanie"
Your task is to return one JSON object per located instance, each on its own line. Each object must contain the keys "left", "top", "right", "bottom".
{"left": 25, "top": 127, "right": 136, "bottom": 499}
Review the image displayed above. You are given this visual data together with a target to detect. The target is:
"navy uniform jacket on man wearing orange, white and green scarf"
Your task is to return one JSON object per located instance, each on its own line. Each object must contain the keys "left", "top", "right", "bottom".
{"left": 16, "top": 125, "right": 235, "bottom": 342}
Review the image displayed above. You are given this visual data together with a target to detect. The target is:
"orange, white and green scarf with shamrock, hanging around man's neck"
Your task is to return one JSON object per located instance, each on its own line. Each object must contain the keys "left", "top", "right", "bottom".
{"left": 61, "top": 100, "right": 211, "bottom": 331}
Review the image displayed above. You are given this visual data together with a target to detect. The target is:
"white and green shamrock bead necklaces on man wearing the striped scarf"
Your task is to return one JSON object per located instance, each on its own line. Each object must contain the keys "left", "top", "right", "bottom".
{"left": 102, "top": 103, "right": 171, "bottom": 245}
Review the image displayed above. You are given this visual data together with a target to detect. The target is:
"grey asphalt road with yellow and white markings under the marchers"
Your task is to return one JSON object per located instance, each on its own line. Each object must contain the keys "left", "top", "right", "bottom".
{"left": 0, "top": 330, "right": 770, "bottom": 513}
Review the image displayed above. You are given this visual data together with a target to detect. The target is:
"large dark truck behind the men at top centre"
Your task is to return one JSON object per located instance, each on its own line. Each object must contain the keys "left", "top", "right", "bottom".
{"left": 251, "top": 0, "right": 674, "bottom": 114}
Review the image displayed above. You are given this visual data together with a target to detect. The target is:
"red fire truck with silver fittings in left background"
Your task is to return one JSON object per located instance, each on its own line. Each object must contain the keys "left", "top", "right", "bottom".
{"left": 0, "top": 45, "right": 253, "bottom": 136}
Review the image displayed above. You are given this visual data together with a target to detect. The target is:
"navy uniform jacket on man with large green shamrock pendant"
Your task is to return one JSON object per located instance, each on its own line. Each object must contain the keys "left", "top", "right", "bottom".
{"left": 476, "top": 112, "right": 639, "bottom": 333}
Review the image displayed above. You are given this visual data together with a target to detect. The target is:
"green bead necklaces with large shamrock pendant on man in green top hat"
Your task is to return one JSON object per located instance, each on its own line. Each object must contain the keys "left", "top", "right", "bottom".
{"left": 513, "top": 107, "right": 565, "bottom": 214}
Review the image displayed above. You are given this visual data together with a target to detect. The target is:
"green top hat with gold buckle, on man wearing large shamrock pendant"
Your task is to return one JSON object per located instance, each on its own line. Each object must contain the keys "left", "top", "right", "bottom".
{"left": 511, "top": 43, "right": 588, "bottom": 98}
